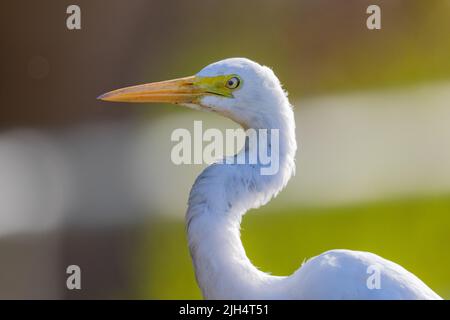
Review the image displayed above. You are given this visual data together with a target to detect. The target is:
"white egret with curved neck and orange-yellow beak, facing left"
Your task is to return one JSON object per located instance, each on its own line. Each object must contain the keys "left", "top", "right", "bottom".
{"left": 99, "top": 58, "right": 441, "bottom": 299}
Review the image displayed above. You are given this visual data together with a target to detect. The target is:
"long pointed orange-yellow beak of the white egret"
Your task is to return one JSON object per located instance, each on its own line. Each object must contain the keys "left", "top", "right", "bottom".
{"left": 98, "top": 76, "right": 208, "bottom": 104}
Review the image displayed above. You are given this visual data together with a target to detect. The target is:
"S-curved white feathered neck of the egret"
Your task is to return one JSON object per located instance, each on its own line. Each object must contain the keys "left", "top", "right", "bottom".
{"left": 186, "top": 104, "right": 297, "bottom": 299}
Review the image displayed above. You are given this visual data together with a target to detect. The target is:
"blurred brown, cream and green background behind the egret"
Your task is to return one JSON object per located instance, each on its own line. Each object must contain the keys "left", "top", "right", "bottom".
{"left": 0, "top": 0, "right": 450, "bottom": 299}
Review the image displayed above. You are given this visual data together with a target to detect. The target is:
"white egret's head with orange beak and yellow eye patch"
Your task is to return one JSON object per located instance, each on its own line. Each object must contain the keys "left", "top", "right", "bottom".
{"left": 99, "top": 58, "right": 289, "bottom": 127}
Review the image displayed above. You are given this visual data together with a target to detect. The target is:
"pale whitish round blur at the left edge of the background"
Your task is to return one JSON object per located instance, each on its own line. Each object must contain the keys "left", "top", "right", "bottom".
{"left": 0, "top": 130, "right": 70, "bottom": 236}
